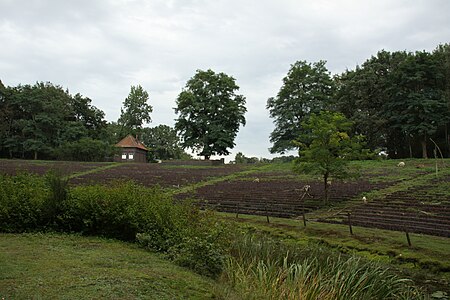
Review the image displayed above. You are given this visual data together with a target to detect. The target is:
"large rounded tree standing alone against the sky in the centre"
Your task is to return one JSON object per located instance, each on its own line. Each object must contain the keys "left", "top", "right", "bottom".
{"left": 175, "top": 70, "right": 247, "bottom": 159}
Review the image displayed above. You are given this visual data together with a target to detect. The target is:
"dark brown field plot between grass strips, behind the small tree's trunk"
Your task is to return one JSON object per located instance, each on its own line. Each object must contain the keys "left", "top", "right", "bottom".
{"left": 179, "top": 179, "right": 388, "bottom": 218}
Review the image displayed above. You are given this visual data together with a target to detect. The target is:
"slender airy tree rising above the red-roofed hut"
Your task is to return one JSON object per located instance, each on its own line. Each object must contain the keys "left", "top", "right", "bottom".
{"left": 117, "top": 85, "right": 153, "bottom": 138}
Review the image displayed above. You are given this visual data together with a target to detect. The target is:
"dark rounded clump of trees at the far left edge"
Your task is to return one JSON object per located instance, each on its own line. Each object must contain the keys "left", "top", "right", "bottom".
{"left": 0, "top": 82, "right": 106, "bottom": 159}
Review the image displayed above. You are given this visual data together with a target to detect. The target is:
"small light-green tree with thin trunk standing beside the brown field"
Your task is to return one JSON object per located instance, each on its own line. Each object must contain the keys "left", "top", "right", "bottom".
{"left": 294, "top": 111, "right": 363, "bottom": 202}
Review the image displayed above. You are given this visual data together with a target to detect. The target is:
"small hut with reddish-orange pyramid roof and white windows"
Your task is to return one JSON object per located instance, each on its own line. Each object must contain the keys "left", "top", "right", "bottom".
{"left": 114, "top": 135, "right": 148, "bottom": 163}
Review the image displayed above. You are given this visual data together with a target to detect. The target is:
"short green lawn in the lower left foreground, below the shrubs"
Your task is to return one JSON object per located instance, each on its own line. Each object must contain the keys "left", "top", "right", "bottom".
{"left": 0, "top": 234, "right": 216, "bottom": 299}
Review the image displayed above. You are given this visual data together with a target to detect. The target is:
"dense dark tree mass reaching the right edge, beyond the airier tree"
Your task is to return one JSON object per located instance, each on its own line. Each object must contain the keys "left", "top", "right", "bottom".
{"left": 334, "top": 45, "right": 450, "bottom": 157}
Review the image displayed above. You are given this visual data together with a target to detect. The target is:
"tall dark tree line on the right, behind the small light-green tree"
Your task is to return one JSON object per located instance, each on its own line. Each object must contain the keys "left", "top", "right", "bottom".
{"left": 267, "top": 44, "right": 450, "bottom": 158}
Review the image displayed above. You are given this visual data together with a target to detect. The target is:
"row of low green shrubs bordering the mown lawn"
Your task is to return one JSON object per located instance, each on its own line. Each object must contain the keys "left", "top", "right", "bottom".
{"left": 0, "top": 173, "right": 229, "bottom": 276}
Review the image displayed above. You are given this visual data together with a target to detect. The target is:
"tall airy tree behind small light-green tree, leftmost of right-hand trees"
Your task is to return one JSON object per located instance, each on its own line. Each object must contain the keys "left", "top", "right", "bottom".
{"left": 266, "top": 60, "right": 334, "bottom": 154}
